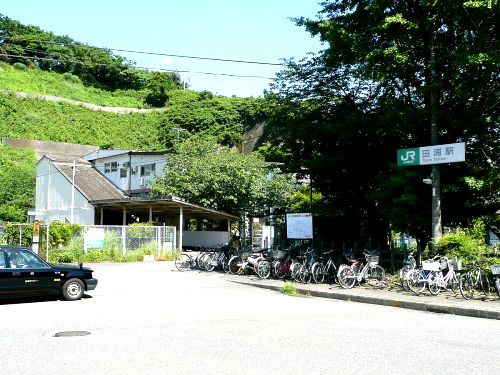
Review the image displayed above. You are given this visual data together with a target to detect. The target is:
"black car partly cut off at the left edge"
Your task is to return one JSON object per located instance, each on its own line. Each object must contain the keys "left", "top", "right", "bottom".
{"left": 0, "top": 246, "right": 97, "bottom": 301}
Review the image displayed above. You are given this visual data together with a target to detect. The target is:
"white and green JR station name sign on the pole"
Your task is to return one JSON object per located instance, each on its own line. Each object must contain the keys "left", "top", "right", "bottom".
{"left": 397, "top": 142, "right": 465, "bottom": 167}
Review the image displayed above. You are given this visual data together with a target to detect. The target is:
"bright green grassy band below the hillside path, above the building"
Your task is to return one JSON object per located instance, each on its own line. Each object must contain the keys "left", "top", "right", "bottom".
{"left": 0, "top": 95, "right": 166, "bottom": 151}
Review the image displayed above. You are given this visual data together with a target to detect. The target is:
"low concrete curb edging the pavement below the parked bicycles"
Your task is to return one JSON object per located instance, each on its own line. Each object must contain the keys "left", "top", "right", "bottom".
{"left": 229, "top": 279, "right": 500, "bottom": 320}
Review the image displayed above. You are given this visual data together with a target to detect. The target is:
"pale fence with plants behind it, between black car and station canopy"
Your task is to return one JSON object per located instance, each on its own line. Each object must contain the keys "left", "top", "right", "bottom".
{"left": 0, "top": 222, "right": 177, "bottom": 259}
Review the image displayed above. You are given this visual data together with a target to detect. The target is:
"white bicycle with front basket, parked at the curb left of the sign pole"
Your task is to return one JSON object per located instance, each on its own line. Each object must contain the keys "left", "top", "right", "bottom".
{"left": 337, "top": 252, "right": 385, "bottom": 289}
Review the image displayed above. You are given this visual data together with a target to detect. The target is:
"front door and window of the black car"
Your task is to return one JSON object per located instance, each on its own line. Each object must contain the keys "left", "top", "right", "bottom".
{"left": 6, "top": 249, "right": 57, "bottom": 296}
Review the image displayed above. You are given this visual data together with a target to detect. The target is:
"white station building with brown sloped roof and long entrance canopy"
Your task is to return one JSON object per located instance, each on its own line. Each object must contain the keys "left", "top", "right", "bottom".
{"left": 34, "top": 150, "right": 238, "bottom": 247}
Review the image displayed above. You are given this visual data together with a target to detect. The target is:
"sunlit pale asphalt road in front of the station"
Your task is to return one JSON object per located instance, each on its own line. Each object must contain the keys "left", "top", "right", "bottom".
{"left": 0, "top": 262, "right": 500, "bottom": 375}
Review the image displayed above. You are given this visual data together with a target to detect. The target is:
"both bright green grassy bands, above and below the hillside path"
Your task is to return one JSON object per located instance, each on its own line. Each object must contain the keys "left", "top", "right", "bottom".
{"left": 0, "top": 63, "right": 172, "bottom": 151}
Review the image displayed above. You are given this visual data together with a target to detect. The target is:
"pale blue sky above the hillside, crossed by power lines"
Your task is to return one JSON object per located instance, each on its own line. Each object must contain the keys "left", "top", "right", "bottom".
{"left": 0, "top": 0, "right": 324, "bottom": 97}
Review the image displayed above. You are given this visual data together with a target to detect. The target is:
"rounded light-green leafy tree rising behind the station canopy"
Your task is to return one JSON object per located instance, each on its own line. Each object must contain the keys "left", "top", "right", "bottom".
{"left": 152, "top": 138, "right": 292, "bottom": 214}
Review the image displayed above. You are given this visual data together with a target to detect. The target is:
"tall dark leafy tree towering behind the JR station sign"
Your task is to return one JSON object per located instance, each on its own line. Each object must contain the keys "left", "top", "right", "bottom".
{"left": 267, "top": 0, "right": 500, "bottom": 251}
